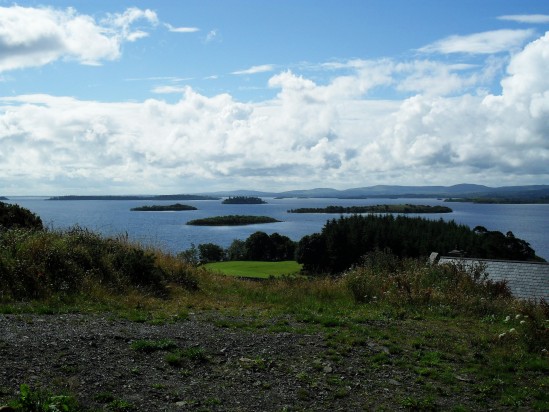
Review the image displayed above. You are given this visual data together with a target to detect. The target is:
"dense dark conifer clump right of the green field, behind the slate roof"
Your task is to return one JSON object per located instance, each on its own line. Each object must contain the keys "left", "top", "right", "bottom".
{"left": 297, "top": 215, "right": 539, "bottom": 273}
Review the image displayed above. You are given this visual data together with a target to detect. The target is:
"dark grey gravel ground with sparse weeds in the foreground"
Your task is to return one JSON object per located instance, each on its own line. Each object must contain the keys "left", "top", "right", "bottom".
{"left": 0, "top": 313, "right": 459, "bottom": 411}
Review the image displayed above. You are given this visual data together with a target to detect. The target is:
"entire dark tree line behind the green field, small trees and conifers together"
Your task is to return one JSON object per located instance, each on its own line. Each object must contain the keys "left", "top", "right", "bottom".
{"left": 183, "top": 215, "right": 543, "bottom": 268}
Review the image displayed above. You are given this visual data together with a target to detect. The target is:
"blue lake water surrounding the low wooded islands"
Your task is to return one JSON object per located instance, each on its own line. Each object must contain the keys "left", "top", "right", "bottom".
{"left": 7, "top": 197, "right": 549, "bottom": 260}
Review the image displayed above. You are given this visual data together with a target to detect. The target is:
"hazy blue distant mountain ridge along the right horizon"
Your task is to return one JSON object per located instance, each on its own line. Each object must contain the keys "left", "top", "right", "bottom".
{"left": 199, "top": 183, "right": 549, "bottom": 199}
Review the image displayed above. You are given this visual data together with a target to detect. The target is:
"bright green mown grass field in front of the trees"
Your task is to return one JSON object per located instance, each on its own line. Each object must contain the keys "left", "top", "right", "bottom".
{"left": 204, "top": 260, "right": 301, "bottom": 278}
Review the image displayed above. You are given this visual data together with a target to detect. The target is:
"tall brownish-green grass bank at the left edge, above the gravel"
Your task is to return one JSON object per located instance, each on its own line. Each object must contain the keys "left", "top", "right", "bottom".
{"left": 0, "top": 227, "right": 197, "bottom": 300}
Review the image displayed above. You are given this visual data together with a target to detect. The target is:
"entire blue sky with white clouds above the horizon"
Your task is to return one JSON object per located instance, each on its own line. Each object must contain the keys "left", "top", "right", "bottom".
{"left": 0, "top": 0, "right": 549, "bottom": 196}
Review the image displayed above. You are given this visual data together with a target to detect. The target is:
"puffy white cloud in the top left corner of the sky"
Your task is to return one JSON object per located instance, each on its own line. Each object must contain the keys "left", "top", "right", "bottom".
{"left": 0, "top": 6, "right": 158, "bottom": 72}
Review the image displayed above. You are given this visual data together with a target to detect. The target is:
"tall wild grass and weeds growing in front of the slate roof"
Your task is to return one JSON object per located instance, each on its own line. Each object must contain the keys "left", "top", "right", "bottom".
{"left": 344, "top": 252, "right": 512, "bottom": 315}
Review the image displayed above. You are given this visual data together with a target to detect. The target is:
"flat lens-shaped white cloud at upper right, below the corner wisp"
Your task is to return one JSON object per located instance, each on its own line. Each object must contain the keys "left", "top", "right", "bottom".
{"left": 419, "top": 29, "right": 534, "bottom": 54}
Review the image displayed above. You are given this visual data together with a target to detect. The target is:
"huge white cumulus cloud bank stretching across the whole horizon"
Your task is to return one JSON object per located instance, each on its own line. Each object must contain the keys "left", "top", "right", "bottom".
{"left": 0, "top": 33, "right": 549, "bottom": 193}
